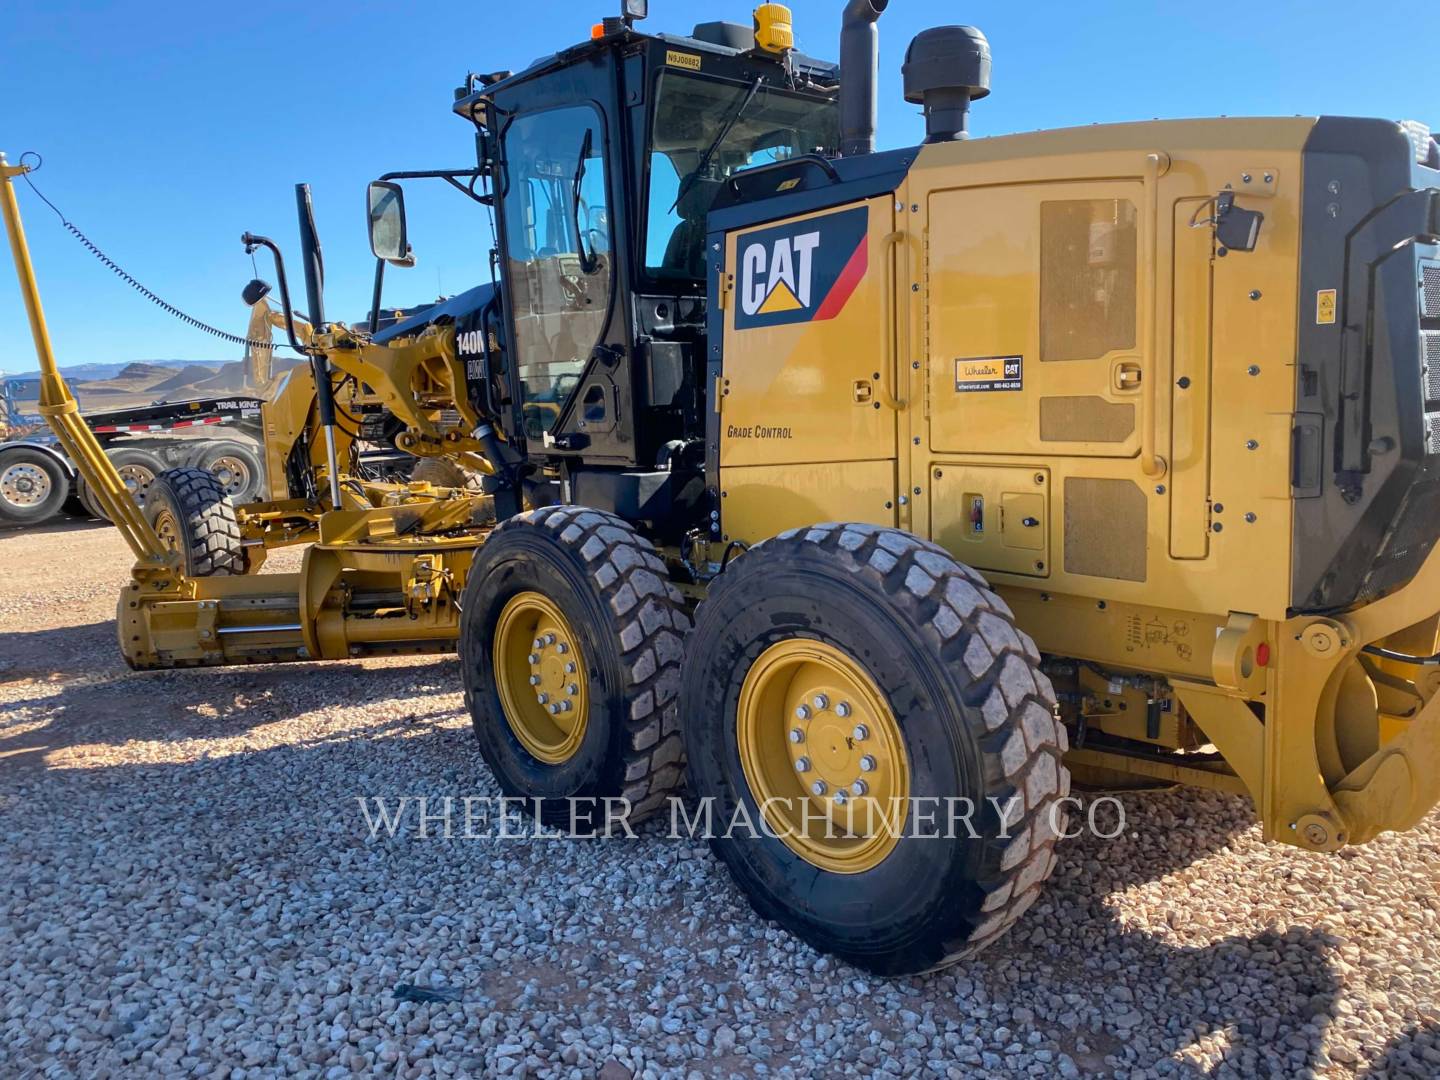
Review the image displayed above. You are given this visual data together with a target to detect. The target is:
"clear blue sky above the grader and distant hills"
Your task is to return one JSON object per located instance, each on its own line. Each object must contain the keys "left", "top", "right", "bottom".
{"left": 0, "top": 0, "right": 1440, "bottom": 372}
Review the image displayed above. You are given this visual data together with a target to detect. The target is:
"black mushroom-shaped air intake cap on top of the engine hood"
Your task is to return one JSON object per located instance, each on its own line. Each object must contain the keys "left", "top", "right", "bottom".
{"left": 898, "top": 26, "right": 989, "bottom": 143}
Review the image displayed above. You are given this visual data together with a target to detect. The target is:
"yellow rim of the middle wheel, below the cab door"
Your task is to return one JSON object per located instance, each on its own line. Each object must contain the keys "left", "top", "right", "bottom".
{"left": 494, "top": 592, "right": 589, "bottom": 765}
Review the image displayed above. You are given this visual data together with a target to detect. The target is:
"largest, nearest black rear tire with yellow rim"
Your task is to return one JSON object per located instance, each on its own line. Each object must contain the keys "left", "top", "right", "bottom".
{"left": 681, "top": 524, "right": 1068, "bottom": 973}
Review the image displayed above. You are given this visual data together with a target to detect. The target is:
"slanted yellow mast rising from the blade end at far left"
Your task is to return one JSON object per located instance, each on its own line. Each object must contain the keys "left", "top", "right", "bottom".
{"left": 0, "top": 154, "right": 172, "bottom": 573}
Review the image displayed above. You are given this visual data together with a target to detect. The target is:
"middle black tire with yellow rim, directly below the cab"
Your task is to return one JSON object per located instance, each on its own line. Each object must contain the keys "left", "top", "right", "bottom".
{"left": 459, "top": 507, "right": 690, "bottom": 828}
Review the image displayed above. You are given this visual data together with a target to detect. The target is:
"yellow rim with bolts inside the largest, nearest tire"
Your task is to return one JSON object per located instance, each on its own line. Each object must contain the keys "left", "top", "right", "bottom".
{"left": 736, "top": 638, "right": 910, "bottom": 874}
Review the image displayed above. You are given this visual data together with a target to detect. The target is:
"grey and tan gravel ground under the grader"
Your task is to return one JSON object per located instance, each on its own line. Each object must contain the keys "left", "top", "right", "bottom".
{"left": 0, "top": 524, "right": 1440, "bottom": 1077}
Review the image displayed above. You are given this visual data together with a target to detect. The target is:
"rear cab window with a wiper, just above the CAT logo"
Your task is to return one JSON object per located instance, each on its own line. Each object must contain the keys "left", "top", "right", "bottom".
{"left": 645, "top": 69, "right": 840, "bottom": 278}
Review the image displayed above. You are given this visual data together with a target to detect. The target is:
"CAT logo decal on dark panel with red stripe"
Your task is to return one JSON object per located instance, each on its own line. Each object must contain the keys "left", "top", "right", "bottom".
{"left": 734, "top": 206, "right": 870, "bottom": 330}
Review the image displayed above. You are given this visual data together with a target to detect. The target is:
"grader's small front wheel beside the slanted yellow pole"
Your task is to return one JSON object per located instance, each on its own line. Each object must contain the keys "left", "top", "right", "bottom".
{"left": 144, "top": 468, "right": 245, "bottom": 577}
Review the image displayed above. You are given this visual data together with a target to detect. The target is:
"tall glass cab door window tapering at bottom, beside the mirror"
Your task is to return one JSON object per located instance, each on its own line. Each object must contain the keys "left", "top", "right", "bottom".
{"left": 501, "top": 105, "right": 613, "bottom": 438}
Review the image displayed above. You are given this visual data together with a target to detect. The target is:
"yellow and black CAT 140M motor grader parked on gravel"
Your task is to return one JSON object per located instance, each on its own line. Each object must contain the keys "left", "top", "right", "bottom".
{"left": 4, "top": 0, "right": 1440, "bottom": 972}
